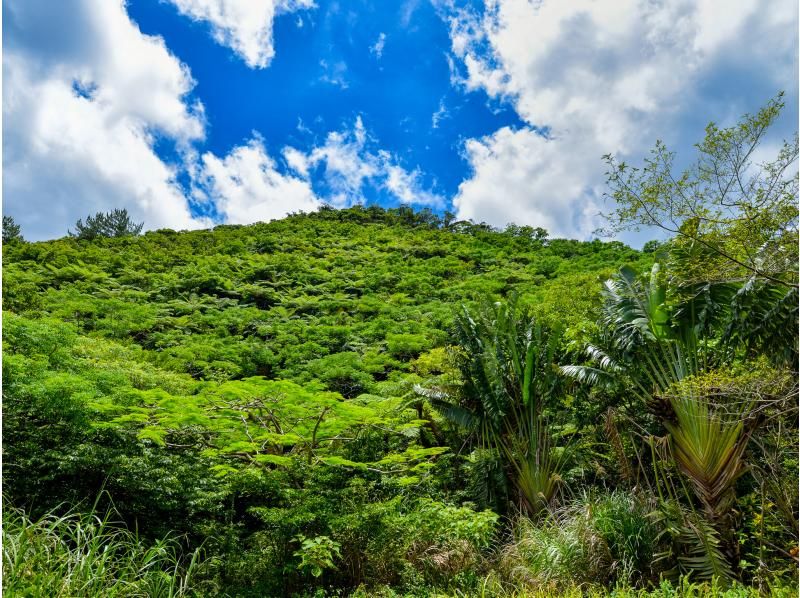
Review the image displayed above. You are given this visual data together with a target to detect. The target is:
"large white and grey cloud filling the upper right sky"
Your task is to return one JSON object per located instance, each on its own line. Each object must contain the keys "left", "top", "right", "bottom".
{"left": 450, "top": 0, "right": 797, "bottom": 237}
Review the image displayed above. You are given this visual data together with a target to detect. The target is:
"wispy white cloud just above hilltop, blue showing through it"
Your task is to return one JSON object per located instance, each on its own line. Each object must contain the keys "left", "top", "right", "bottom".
{"left": 284, "top": 116, "right": 444, "bottom": 207}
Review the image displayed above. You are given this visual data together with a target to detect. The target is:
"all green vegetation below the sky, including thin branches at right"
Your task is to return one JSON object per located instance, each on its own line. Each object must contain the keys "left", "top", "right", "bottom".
{"left": 3, "top": 98, "right": 798, "bottom": 597}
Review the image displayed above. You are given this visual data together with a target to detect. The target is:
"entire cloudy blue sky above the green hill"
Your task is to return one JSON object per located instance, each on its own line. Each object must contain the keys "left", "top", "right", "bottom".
{"left": 2, "top": 0, "right": 798, "bottom": 245}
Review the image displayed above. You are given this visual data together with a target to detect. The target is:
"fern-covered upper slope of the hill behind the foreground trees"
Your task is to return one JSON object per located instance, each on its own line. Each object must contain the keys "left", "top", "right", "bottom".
{"left": 3, "top": 209, "right": 642, "bottom": 396}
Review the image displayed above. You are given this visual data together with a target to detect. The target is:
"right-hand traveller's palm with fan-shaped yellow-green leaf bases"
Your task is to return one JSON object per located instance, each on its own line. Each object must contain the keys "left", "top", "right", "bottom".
{"left": 561, "top": 264, "right": 752, "bottom": 577}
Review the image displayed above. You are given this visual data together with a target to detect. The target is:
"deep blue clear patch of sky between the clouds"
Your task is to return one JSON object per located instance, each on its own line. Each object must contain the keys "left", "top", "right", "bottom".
{"left": 128, "top": 0, "right": 523, "bottom": 210}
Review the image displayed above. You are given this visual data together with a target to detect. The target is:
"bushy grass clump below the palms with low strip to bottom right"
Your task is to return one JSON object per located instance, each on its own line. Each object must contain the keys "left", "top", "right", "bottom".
{"left": 472, "top": 491, "right": 797, "bottom": 598}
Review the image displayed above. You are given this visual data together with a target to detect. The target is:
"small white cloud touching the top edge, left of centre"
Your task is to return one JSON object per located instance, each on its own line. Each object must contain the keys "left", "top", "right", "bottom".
{"left": 169, "top": 0, "right": 314, "bottom": 68}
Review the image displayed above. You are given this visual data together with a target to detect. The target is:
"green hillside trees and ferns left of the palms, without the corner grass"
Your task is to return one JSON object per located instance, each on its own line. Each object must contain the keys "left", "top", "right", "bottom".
{"left": 3, "top": 209, "right": 651, "bottom": 596}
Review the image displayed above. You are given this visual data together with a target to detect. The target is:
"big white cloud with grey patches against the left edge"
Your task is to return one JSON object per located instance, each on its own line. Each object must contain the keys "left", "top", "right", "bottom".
{"left": 3, "top": 0, "right": 205, "bottom": 240}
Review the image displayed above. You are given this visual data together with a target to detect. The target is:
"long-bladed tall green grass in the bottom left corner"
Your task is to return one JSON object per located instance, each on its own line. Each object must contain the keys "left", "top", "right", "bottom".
{"left": 3, "top": 507, "right": 198, "bottom": 598}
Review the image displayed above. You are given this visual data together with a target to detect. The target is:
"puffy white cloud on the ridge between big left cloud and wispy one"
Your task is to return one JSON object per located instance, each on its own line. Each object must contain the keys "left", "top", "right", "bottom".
{"left": 199, "top": 138, "right": 320, "bottom": 224}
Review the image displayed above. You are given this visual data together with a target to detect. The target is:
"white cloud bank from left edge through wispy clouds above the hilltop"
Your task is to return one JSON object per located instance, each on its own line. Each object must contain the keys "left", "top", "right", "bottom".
{"left": 3, "top": 0, "right": 443, "bottom": 240}
